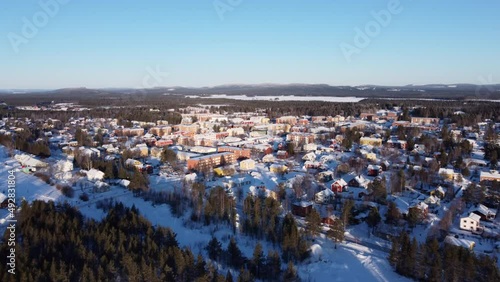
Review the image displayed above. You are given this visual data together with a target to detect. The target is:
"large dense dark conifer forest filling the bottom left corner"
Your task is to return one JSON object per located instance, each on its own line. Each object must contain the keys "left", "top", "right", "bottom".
{"left": 0, "top": 201, "right": 225, "bottom": 281}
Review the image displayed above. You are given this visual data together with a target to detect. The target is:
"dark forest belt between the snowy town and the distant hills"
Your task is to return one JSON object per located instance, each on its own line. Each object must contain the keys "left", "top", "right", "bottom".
{"left": 0, "top": 93, "right": 500, "bottom": 126}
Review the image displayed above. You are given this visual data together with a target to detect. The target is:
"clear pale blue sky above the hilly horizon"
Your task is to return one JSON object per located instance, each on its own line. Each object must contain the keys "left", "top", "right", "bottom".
{"left": 0, "top": 0, "right": 500, "bottom": 89}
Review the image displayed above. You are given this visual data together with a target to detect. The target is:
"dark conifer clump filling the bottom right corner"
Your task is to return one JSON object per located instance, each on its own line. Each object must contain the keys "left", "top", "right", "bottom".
{"left": 389, "top": 231, "right": 500, "bottom": 282}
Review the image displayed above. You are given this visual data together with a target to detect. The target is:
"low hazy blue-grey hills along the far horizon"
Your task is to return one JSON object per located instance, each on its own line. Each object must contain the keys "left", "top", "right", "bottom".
{"left": 0, "top": 84, "right": 500, "bottom": 100}
